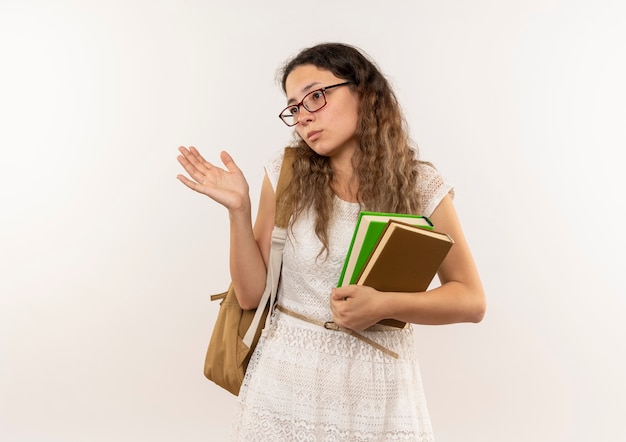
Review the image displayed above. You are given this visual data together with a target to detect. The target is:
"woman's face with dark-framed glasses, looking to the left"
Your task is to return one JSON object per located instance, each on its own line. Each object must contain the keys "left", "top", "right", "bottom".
{"left": 285, "top": 64, "right": 359, "bottom": 161}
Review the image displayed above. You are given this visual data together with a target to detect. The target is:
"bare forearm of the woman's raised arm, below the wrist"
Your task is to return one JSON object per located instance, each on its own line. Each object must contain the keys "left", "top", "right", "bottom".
{"left": 229, "top": 205, "right": 267, "bottom": 309}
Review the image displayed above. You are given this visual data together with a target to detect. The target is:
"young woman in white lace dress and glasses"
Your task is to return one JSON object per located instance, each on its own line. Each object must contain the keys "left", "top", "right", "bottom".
{"left": 179, "top": 44, "right": 485, "bottom": 442}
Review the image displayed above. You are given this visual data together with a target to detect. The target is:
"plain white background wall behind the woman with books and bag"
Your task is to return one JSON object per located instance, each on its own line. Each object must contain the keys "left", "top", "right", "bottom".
{"left": 0, "top": 0, "right": 626, "bottom": 442}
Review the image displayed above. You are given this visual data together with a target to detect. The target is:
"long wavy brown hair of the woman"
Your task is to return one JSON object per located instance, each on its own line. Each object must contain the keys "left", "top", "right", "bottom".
{"left": 279, "top": 43, "right": 422, "bottom": 253}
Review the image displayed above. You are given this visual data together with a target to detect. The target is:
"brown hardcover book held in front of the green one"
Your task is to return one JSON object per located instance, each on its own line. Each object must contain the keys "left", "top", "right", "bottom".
{"left": 357, "top": 220, "right": 454, "bottom": 327}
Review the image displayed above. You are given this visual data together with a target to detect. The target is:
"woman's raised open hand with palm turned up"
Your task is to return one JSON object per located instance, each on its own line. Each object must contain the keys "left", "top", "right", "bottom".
{"left": 176, "top": 146, "right": 250, "bottom": 210}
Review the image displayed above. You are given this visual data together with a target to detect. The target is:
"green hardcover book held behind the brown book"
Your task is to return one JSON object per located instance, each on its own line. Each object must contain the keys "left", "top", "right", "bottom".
{"left": 337, "top": 211, "right": 433, "bottom": 287}
